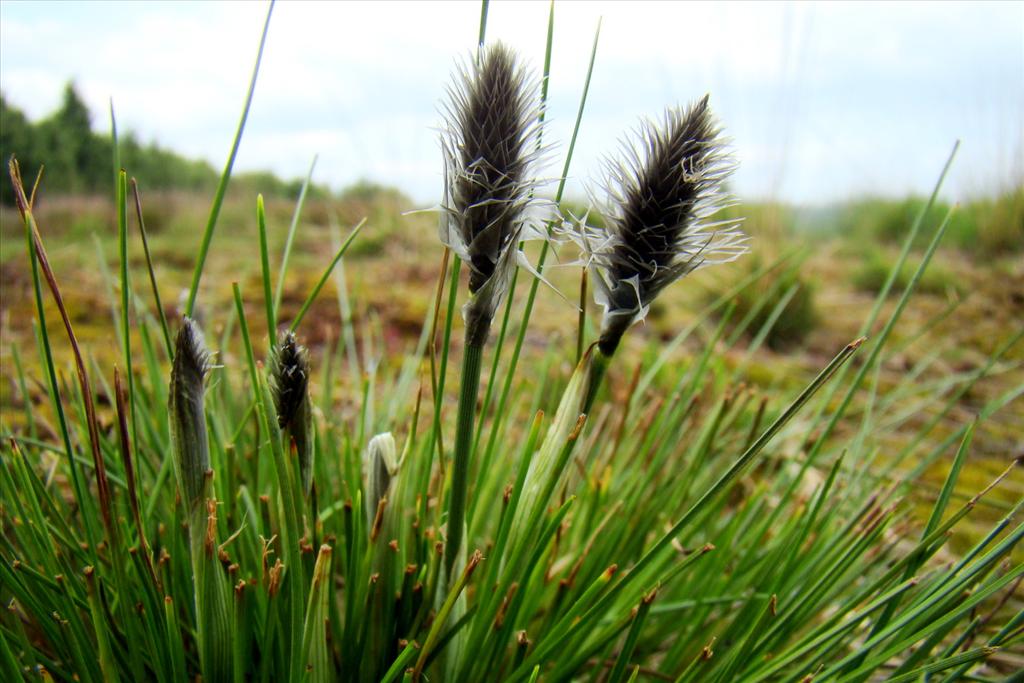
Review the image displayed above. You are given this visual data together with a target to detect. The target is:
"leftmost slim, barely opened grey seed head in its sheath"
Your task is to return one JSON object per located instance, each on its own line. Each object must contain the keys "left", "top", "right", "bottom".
{"left": 168, "top": 317, "right": 210, "bottom": 510}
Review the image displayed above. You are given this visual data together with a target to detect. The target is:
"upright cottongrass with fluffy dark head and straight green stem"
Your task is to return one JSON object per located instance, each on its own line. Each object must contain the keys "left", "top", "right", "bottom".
{"left": 440, "top": 43, "right": 543, "bottom": 572}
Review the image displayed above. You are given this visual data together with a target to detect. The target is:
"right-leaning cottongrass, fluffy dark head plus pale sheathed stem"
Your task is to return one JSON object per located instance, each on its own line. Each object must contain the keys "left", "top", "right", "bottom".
{"left": 524, "top": 95, "right": 746, "bottom": 532}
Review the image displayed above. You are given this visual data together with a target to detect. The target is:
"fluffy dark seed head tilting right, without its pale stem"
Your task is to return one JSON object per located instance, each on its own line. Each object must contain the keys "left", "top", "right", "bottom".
{"left": 577, "top": 96, "right": 746, "bottom": 354}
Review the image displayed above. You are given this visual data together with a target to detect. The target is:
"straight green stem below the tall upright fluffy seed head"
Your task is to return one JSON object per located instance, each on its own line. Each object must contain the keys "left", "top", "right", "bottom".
{"left": 444, "top": 344, "right": 483, "bottom": 574}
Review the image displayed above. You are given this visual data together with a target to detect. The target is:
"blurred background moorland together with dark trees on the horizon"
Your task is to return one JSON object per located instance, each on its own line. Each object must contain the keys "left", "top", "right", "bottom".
{"left": 0, "top": 84, "right": 1024, "bottom": 548}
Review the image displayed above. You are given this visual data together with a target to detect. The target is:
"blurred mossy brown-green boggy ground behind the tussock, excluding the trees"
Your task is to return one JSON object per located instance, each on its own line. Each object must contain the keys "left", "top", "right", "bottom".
{"left": 0, "top": 188, "right": 1024, "bottom": 548}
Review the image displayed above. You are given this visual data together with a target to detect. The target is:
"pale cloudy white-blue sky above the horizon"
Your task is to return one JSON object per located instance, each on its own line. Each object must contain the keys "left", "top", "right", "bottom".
{"left": 0, "top": 0, "right": 1024, "bottom": 206}
